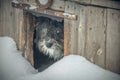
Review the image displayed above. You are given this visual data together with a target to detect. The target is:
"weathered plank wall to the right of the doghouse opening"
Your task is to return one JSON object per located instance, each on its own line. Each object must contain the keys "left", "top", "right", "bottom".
{"left": 65, "top": 0, "right": 120, "bottom": 73}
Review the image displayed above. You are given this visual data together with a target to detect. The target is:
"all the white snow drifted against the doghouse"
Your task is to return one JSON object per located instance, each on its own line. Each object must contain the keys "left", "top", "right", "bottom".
{"left": 0, "top": 37, "right": 120, "bottom": 80}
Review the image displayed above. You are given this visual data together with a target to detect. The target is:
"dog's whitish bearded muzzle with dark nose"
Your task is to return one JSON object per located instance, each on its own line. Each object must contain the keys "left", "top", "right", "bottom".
{"left": 38, "top": 39, "right": 63, "bottom": 60}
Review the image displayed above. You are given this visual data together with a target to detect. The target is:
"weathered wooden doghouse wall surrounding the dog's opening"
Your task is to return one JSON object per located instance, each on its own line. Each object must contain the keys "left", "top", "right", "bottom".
{"left": 0, "top": 0, "right": 120, "bottom": 73}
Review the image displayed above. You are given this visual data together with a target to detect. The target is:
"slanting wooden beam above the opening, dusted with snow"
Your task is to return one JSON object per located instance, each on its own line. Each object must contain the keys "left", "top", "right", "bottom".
{"left": 12, "top": 2, "right": 77, "bottom": 20}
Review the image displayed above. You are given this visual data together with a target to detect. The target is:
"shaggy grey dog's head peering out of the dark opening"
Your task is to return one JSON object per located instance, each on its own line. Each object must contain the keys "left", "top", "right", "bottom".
{"left": 36, "top": 19, "right": 64, "bottom": 60}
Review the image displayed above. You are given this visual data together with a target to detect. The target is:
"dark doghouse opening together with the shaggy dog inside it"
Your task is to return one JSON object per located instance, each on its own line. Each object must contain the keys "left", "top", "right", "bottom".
{"left": 34, "top": 17, "right": 64, "bottom": 71}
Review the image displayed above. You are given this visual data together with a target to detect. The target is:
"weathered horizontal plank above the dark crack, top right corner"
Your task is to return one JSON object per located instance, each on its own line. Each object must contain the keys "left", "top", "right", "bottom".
{"left": 68, "top": 0, "right": 120, "bottom": 10}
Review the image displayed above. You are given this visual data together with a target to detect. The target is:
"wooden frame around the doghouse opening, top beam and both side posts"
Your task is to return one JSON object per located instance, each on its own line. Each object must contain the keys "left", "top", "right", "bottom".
{"left": 12, "top": 2, "right": 76, "bottom": 69}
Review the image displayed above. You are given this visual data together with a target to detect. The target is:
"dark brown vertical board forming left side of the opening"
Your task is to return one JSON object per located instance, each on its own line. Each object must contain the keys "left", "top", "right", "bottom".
{"left": 26, "top": 13, "right": 34, "bottom": 65}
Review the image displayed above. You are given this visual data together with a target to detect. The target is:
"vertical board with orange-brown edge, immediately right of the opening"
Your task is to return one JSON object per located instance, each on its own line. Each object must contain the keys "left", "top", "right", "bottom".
{"left": 64, "top": 1, "right": 80, "bottom": 55}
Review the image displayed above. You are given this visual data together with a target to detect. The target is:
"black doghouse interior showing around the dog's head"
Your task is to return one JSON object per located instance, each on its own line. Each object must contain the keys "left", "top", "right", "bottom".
{"left": 33, "top": 14, "right": 64, "bottom": 72}
